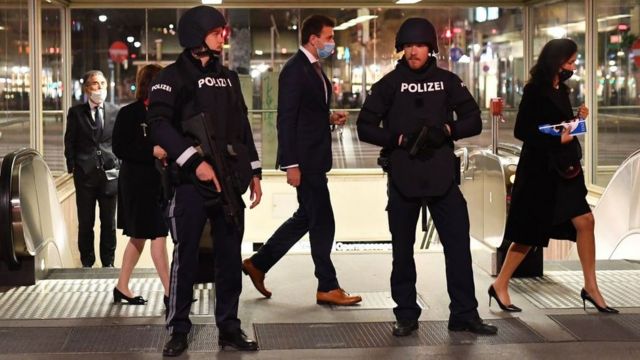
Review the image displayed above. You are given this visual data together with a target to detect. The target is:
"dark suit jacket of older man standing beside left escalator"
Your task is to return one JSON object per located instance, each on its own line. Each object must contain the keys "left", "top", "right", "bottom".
{"left": 64, "top": 102, "right": 118, "bottom": 174}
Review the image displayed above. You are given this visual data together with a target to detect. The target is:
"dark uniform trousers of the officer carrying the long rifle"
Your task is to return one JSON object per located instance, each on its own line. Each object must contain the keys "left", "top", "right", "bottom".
{"left": 167, "top": 184, "right": 244, "bottom": 334}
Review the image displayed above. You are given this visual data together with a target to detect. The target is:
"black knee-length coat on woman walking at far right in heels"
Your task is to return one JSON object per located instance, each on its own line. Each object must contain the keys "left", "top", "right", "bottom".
{"left": 504, "top": 83, "right": 588, "bottom": 246}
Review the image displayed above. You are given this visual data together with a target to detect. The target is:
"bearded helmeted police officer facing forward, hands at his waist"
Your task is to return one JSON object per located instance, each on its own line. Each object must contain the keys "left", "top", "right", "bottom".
{"left": 357, "top": 18, "right": 497, "bottom": 336}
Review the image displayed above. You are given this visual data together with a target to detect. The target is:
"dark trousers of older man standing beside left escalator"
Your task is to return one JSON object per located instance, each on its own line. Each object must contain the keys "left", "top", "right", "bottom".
{"left": 73, "top": 167, "right": 117, "bottom": 267}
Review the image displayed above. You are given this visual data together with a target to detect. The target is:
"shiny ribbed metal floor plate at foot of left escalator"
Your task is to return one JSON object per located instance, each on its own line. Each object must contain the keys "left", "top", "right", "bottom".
{"left": 0, "top": 278, "right": 214, "bottom": 320}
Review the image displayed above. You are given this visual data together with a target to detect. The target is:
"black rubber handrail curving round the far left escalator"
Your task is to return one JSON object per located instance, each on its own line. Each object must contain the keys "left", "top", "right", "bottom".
{"left": 0, "top": 148, "right": 41, "bottom": 268}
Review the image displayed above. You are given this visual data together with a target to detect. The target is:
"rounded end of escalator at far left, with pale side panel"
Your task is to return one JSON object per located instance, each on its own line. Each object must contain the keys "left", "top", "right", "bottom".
{"left": 0, "top": 149, "right": 73, "bottom": 286}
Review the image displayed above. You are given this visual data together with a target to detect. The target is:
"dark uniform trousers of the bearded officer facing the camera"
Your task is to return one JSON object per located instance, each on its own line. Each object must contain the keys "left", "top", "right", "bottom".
{"left": 387, "top": 183, "right": 478, "bottom": 324}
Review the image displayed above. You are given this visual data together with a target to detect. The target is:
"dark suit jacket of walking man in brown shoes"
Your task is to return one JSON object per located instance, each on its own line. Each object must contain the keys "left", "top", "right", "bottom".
{"left": 276, "top": 50, "right": 331, "bottom": 173}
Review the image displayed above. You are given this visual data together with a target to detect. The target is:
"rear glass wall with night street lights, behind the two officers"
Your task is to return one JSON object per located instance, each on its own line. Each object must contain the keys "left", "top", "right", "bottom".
{"left": 71, "top": 7, "right": 525, "bottom": 168}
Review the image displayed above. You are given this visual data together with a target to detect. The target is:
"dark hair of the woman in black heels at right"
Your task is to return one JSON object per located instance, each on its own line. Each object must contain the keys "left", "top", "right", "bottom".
{"left": 529, "top": 39, "right": 578, "bottom": 88}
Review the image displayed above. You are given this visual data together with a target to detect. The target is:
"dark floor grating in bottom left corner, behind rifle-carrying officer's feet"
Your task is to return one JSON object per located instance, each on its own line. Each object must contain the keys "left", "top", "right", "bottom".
{"left": 0, "top": 325, "right": 218, "bottom": 354}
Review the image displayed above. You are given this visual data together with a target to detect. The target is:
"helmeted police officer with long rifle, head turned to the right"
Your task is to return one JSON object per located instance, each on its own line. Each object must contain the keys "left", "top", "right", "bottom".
{"left": 147, "top": 6, "right": 262, "bottom": 356}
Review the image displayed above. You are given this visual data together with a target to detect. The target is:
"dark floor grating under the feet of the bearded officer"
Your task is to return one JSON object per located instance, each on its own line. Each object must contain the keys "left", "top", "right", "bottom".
{"left": 253, "top": 318, "right": 545, "bottom": 350}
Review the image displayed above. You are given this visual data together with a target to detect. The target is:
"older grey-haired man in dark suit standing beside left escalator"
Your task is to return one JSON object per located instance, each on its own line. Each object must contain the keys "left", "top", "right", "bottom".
{"left": 64, "top": 70, "right": 118, "bottom": 267}
